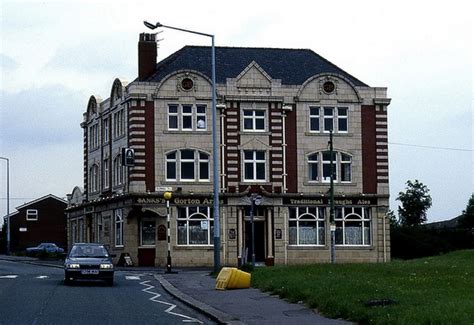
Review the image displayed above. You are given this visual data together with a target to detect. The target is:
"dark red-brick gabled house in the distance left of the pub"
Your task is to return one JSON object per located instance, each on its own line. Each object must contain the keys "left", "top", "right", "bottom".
{"left": 10, "top": 194, "right": 67, "bottom": 252}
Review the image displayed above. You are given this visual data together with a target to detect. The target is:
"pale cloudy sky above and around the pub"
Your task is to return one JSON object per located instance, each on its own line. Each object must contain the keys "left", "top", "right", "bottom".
{"left": 0, "top": 0, "right": 474, "bottom": 222}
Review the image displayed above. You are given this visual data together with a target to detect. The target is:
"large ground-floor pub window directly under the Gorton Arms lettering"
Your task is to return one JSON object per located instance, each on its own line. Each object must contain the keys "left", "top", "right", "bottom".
{"left": 178, "top": 206, "right": 214, "bottom": 245}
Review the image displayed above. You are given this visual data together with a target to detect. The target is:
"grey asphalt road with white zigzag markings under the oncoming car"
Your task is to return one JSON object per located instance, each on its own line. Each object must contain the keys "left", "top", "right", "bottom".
{"left": 0, "top": 260, "right": 214, "bottom": 325}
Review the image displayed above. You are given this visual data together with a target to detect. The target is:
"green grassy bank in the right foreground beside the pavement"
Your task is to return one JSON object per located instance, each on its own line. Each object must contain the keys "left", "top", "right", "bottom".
{"left": 252, "top": 250, "right": 474, "bottom": 324}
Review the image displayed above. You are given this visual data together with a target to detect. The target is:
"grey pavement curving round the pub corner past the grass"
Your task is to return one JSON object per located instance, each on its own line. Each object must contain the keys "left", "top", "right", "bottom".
{"left": 0, "top": 255, "right": 351, "bottom": 325}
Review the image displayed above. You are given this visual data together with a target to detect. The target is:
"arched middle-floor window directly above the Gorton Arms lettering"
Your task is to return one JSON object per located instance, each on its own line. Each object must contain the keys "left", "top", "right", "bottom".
{"left": 165, "top": 149, "right": 209, "bottom": 182}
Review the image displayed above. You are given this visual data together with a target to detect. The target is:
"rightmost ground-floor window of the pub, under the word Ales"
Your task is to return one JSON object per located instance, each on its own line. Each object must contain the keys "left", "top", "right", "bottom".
{"left": 334, "top": 207, "right": 372, "bottom": 246}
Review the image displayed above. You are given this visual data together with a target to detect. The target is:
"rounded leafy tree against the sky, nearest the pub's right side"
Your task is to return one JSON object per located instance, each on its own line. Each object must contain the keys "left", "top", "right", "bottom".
{"left": 397, "top": 180, "right": 431, "bottom": 226}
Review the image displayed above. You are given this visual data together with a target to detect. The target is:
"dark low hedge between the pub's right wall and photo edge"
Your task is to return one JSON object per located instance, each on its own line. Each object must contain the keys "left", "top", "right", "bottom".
{"left": 390, "top": 226, "right": 474, "bottom": 259}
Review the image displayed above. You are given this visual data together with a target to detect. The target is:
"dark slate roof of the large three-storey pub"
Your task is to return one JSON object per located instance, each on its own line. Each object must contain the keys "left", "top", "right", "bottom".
{"left": 145, "top": 46, "right": 367, "bottom": 87}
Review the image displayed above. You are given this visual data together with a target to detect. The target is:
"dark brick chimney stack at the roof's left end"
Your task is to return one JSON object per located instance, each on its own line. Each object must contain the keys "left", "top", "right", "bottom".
{"left": 138, "top": 33, "right": 157, "bottom": 81}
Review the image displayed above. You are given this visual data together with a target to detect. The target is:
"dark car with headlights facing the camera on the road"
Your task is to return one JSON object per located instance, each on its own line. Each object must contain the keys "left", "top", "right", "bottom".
{"left": 64, "top": 243, "right": 114, "bottom": 286}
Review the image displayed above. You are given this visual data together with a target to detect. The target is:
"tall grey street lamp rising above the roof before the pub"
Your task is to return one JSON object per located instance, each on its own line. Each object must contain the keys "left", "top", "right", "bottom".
{"left": 143, "top": 21, "right": 221, "bottom": 272}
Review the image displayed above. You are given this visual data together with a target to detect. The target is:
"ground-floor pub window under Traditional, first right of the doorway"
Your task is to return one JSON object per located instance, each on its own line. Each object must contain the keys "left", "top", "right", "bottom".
{"left": 289, "top": 207, "right": 325, "bottom": 245}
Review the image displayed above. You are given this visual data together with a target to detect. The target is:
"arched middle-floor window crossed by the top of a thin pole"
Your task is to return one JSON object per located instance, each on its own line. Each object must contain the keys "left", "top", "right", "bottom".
{"left": 306, "top": 151, "right": 352, "bottom": 183}
